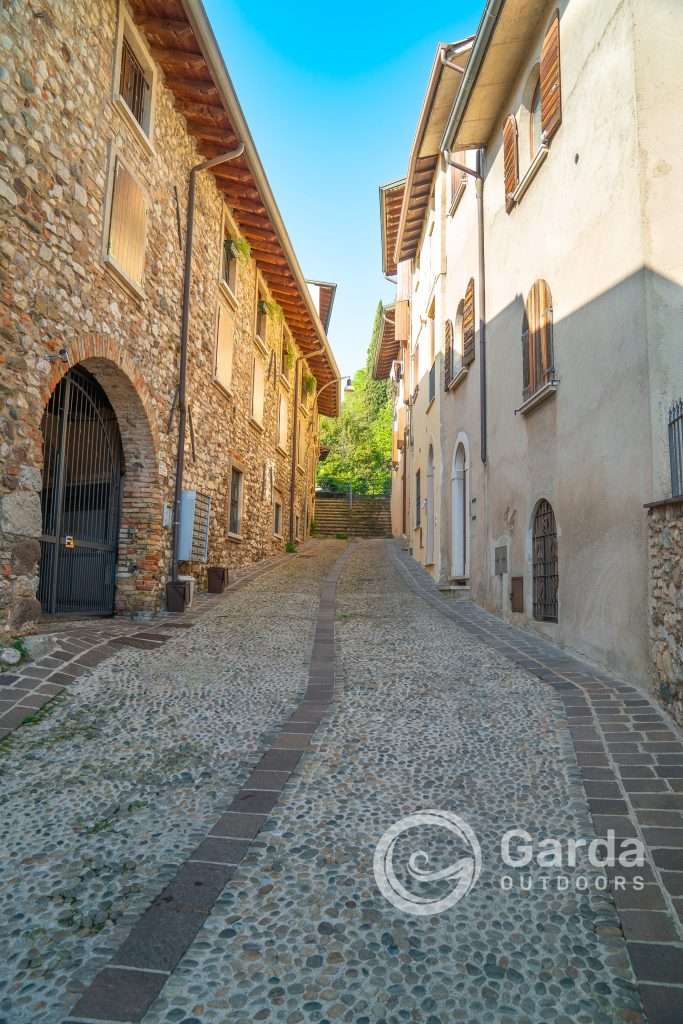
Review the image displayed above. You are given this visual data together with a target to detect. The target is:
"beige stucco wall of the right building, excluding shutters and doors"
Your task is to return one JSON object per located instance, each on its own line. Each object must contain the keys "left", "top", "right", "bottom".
{"left": 393, "top": 0, "right": 683, "bottom": 682}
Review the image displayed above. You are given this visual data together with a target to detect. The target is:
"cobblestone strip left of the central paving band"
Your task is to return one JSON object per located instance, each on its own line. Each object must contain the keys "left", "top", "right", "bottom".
{"left": 0, "top": 543, "right": 344, "bottom": 1024}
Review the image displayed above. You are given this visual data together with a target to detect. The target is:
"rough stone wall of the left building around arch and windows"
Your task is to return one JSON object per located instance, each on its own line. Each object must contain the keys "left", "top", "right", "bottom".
{"left": 0, "top": 0, "right": 317, "bottom": 634}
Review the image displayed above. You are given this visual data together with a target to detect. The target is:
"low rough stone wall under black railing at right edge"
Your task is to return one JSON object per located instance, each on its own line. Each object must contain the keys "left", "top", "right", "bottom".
{"left": 648, "top": 498, "right": 683, "bottom": 725}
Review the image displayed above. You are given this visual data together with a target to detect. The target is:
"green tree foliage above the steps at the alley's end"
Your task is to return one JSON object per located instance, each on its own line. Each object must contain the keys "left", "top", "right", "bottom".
{"left": 317, "top": 302, "right": 393, "bottom": 495}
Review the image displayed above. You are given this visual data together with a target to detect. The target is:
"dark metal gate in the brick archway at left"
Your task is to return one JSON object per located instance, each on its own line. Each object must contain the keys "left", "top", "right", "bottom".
{"left": 38, "top": 368, "right": 123, "bottom": 615}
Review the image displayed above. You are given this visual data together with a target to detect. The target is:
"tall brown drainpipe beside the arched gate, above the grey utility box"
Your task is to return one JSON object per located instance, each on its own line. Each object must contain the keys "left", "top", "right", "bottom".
{"left": 171, "top": 144, "right": 245, "bottom": 583}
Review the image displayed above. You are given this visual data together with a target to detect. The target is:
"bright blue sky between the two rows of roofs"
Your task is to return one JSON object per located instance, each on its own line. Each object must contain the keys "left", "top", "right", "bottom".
{"left": 205, "top": 0, "right": 483, "bottom": 373}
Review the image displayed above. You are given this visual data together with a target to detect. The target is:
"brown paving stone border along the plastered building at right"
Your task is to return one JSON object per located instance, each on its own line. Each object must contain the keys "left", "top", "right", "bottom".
{"left": 387, "top": 542, "right": 683, "bottom": 1024}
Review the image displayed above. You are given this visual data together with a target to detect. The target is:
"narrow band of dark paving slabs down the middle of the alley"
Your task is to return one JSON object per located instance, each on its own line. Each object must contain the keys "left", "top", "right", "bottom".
{"left": 63, "top": 545, "right": 352, "bottom": 1024}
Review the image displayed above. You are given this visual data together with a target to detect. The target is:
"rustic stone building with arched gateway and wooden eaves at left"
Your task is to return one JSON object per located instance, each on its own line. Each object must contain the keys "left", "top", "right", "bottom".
{"left": 0, "top": 0, "right": 339, "bottom": 633}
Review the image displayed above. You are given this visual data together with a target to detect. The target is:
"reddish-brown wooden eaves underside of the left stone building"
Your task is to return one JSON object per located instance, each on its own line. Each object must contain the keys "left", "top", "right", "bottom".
{"left": 131, "top": 0, "right": 338, "bottom": 416}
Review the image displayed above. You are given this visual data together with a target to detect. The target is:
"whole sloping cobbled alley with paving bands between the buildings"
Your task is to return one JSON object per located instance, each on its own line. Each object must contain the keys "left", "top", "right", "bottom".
{"left": 0, "top": 541, "right": 683, "bottom": 1024}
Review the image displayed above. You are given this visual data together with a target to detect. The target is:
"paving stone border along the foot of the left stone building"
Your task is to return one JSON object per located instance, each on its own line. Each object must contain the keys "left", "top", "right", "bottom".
{"left": 0, "top": 555, "right": 292, "bottom": 741}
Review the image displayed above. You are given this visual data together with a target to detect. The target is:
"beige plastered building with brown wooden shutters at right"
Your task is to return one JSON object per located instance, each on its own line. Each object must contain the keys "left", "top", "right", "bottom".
{"left": 378, "top": 0, "right": 683, "bottom": 683}
